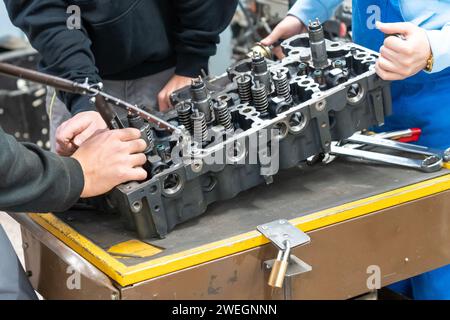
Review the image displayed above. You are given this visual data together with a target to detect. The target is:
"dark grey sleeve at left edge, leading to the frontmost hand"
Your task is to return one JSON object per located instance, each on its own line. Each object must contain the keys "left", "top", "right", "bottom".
{"left": 0, "top": 128, "right": 84, "bottom": 212}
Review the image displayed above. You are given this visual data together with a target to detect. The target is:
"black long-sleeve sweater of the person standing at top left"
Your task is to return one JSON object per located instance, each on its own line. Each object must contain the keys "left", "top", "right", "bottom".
{"left": 4, "top": 0, "right": 237, "bottom": 114}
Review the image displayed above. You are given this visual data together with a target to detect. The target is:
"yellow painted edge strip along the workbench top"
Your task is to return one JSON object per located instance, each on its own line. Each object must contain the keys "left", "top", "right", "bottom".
{"left": 30, "top": 174, "right": 450, "bottom": 286}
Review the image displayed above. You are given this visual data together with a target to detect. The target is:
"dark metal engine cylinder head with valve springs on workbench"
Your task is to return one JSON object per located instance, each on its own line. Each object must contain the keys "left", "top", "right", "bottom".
{"left": 107, "top": 24, "right": 391, "bottom": 239}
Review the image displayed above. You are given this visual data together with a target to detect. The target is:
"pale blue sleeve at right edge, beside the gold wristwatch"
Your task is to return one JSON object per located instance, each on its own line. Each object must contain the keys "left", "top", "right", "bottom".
{"left": 427, "top": 22, "right": 450, "bottom": 73}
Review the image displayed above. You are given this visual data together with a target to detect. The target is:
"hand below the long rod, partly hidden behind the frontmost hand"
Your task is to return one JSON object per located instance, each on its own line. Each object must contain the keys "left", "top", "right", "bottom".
{"left": 56, "top": 111, "right": 107, "bottom": 157}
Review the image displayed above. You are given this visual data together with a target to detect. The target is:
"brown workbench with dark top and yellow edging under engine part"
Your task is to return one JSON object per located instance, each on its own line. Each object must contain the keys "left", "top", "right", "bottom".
{"left": 8, "top": 160, "right": 450, "bottom": 299}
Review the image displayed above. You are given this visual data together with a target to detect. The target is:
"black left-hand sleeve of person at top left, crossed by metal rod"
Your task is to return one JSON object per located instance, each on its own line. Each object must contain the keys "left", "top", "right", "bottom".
{"left": 4, "top": 0, "right": 101, "bottom": 114}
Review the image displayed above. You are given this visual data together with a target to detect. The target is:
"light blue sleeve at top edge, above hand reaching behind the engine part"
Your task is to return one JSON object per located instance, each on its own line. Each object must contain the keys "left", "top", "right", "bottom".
{"left": 289, "top": 0, "right": 342, "bottom": 25}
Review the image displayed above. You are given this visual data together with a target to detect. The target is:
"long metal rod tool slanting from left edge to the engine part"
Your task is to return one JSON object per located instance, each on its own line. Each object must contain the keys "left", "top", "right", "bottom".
{"left": 0, "top": 62, "right": 181, "bottom": 132}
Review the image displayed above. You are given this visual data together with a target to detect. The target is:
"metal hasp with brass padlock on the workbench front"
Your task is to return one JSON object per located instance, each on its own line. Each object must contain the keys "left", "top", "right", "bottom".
{"left": 257, "top": 219, "right": 312, "bottom": 288}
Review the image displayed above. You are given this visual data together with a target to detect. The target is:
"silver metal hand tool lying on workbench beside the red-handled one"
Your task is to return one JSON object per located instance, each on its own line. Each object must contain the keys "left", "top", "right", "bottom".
{"left": 330, "top": 134, "right": 450, "bottom": 172}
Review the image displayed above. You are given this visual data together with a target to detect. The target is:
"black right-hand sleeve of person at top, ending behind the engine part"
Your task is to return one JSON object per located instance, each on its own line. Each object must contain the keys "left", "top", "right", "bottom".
{"left": 174, "top": 0, "right": 237, "bottom": 77}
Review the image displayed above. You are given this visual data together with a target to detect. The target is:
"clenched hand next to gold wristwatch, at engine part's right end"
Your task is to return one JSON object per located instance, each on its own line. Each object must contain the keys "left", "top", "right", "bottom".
{"left": 375, "top": 22, "right": 431, "bottom": 81}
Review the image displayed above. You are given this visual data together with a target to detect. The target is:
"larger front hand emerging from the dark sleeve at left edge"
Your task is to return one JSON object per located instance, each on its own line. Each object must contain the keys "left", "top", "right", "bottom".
{"left": 72, "top": 128, "right": 147, "bottom": 198}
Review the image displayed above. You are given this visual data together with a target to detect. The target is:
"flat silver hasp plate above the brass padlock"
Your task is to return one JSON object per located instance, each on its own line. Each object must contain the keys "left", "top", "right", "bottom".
{"left": 256, "top": 219, "right": 311, "bottom": 251}
